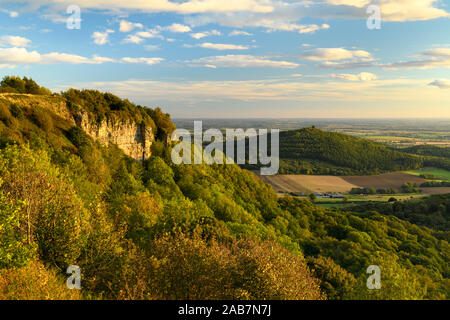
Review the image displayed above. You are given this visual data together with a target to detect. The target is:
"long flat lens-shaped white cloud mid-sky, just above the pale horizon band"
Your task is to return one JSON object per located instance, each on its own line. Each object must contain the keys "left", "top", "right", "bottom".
{"left": 186, "top": 55, "right": 300, "bottom": 69}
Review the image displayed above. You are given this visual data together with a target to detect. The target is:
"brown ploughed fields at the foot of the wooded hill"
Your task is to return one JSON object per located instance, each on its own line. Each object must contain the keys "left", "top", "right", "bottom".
{"left": 259, "top": 172, "right": 450, "bottom": 194}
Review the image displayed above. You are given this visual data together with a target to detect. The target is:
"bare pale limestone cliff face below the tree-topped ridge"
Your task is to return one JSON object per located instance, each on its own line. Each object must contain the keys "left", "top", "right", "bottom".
{"left": 74, "top": 113, "right": 155, "bottom": 161}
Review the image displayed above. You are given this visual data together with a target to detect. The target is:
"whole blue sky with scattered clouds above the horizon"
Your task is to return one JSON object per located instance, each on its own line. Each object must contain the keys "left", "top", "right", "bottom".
{"left": 0, "top": 0, "right": 450, "bottom": 118}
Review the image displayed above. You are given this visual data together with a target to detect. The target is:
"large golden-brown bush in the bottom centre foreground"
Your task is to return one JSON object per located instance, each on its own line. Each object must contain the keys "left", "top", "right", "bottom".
{"left": 148, "top": 231, "right": 324, "bottom": 300}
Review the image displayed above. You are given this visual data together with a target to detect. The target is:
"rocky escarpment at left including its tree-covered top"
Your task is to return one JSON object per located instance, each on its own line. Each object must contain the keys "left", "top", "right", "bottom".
{"left": 0, "top": 89, "right": 174, "bottom": 161}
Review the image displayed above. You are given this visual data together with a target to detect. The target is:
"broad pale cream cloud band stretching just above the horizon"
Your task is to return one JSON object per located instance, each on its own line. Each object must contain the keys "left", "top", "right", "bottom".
{"left": 66, "top": 79, "right": 450, "bottom": 118}
